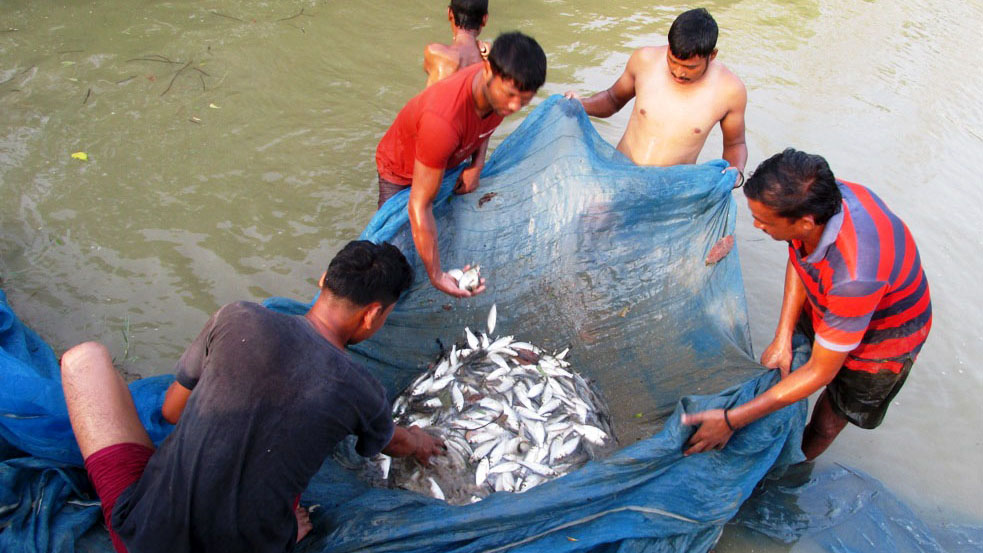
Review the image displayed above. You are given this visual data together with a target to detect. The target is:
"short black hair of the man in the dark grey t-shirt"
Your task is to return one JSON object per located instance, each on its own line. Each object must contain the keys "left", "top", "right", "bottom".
{"left": 324, "top": 240, "right": 413, "bottom": 307}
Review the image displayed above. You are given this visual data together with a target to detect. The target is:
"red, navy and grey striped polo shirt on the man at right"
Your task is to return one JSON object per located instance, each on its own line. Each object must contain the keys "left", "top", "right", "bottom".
{"left": 789, "top": 181, "right": 932, "bottom": 372}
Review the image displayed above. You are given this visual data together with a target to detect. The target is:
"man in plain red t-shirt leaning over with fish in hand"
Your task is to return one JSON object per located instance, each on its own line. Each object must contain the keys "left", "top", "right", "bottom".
{"left": 375, "top": 32, "right": 546, "bottom": 297}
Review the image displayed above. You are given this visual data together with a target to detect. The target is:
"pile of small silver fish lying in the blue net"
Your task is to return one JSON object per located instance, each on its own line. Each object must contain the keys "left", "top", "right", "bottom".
{"left": 376, "top": 306, "right": 617, "bottom": 505}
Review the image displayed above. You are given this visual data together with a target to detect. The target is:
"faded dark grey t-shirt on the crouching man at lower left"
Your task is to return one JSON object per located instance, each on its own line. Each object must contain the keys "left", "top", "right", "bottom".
{"left": 112, "top": 302, "right": 394, "bottom": 553}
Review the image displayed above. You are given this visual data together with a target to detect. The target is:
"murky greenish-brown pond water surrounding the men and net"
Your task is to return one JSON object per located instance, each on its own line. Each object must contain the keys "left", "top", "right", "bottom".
{"left": 0, "top": 0, "right": 983, "bottom": 551}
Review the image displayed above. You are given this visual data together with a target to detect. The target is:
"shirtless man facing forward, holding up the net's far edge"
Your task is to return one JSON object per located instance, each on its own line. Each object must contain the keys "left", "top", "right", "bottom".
{"left": 566, "top": 8, "right": 747, "bottom": 179}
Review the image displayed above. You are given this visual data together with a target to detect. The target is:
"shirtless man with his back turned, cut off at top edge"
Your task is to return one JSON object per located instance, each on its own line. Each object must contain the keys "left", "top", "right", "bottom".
{"left": 423, "top": 0, "right": 489, "bottom": 86}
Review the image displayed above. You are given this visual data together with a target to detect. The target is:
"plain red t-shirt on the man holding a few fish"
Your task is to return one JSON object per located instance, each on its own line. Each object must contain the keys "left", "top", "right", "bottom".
{"left": 375, "top": 63, "right": 502, "bottom": 185}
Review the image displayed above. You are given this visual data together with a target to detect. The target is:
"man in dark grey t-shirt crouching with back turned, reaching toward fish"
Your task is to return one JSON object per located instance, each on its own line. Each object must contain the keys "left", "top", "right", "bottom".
{"left": 62, "top": 241, "right": 442, "bottom": 553}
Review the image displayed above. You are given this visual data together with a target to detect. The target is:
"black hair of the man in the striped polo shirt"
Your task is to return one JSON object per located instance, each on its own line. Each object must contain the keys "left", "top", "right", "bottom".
{"left": 744, "top": 148, "right": 843, "bottom": 225}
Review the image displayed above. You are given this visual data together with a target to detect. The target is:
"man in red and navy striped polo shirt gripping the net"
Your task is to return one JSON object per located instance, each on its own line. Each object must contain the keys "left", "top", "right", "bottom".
{"left": 683, "top": 148, "right": 932, "bottom": 460}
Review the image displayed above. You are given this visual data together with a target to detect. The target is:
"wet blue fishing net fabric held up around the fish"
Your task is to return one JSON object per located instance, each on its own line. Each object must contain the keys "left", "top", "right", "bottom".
{"left": 0, "top": 97, "right": 979, "bottom": 553}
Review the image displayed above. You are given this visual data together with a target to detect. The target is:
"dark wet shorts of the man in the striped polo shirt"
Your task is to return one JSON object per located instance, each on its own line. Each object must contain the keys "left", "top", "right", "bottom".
{"left": 793, "top": 316, "right": 915, "bottom": 429}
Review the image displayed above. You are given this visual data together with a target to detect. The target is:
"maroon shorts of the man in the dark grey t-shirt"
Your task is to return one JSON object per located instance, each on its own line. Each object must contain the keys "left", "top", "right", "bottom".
{"left": 85, "top": 443, "right": 154, "bottom": 553}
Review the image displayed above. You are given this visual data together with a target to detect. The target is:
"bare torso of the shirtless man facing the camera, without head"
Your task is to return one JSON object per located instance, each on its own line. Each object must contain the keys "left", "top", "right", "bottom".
{"left": 618, "top": 46, "right": 747, "bottom": 170}
